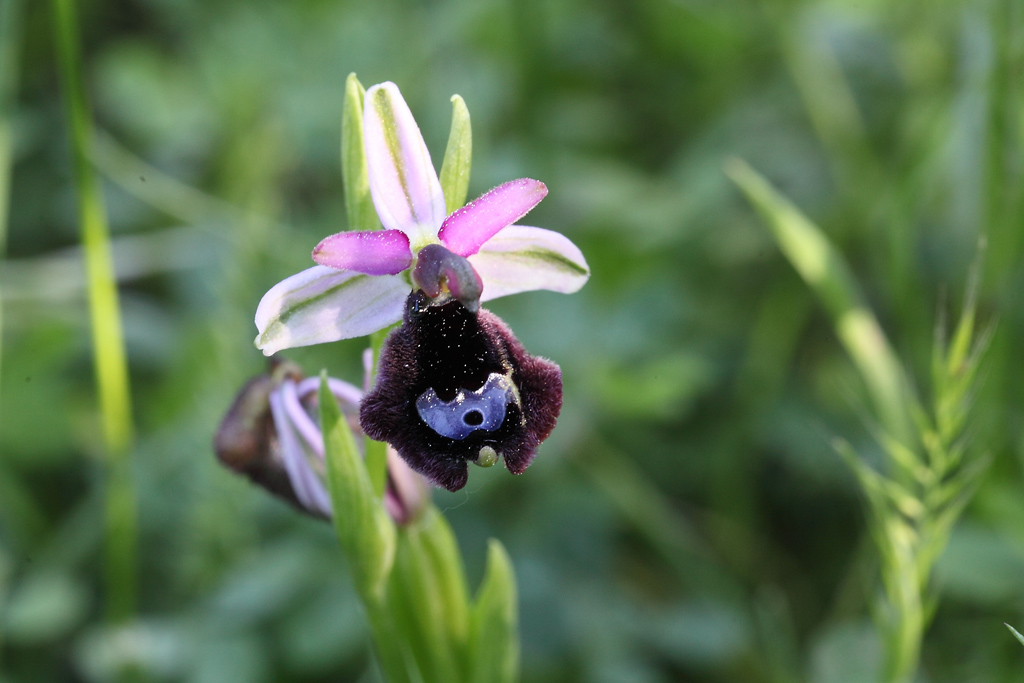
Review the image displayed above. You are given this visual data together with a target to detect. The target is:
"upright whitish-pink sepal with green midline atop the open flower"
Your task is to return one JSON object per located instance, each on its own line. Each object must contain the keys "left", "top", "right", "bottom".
{"left": 362, "top": 83, "right": 445, "bottom": 247}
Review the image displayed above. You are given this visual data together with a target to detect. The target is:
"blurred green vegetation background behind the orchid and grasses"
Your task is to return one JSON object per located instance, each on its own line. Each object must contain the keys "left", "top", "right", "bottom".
{"left": 0, "top": 0, "right": 1024, "bottom": 683}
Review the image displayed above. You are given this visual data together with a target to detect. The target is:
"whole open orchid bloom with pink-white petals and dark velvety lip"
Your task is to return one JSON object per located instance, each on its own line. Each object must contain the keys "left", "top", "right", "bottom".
{"left": 247, "top": 83, "right": 590, "bottom": 490}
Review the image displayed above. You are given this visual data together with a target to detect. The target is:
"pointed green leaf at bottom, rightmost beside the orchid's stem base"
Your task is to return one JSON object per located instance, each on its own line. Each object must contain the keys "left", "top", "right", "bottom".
{"left": 469, "top": 539, "right": 519, "bottom": 683}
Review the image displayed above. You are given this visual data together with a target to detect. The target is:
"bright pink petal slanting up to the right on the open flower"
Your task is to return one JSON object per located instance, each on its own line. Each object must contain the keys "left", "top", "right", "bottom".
{"left": 438, "top": 178, "right": 548, "bottom": 256}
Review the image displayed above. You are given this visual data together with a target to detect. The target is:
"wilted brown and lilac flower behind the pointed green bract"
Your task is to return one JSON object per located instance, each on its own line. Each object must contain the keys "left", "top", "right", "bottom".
{"left": 214, "top": 349, "right": 429, "bottom": 524}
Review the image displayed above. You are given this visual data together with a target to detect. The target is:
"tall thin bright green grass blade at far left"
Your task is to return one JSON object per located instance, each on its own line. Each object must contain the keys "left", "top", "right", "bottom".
{"left": 52, "top": 0, "right": 136, "bottom": 620}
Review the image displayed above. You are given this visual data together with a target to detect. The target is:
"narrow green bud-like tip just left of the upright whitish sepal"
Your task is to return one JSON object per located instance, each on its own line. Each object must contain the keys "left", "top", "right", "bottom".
{"left": 341, "top": 74, "right": 381, "bottom": 230}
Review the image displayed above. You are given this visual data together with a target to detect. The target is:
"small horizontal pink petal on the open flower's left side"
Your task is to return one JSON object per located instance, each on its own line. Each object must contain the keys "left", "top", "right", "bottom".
{"left": 313, "top": 230, "right": 413, "bottom": 275}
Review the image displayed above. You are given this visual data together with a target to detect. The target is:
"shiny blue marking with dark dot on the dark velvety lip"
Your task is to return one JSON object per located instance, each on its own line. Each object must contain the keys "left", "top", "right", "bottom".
{"left": 416, "top": 373, "right": 516, "bottom": 441}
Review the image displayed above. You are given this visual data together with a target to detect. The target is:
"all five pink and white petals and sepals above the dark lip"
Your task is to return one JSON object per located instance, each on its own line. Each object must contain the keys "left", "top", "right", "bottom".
{"left": 256, "top": 82, "right": 590, "bottom": 355}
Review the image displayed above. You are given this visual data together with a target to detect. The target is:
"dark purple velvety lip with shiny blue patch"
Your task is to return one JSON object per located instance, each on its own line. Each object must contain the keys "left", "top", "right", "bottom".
{"left": 359, "top": 291, "right": 562, "bottom": 490}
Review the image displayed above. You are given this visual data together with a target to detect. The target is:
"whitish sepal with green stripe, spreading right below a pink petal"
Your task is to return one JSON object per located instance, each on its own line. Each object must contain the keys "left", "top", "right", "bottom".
{"left": 469, "top": 225, "right": 590, "bottom": 301}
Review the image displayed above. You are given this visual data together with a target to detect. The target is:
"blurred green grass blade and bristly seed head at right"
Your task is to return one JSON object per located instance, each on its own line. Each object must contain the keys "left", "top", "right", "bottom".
{"left": 729, "top": 162, "right": 991, "bottom": 683}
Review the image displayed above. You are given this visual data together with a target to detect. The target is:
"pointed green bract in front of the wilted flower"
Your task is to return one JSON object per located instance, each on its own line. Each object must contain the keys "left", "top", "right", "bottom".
{"left": 319, "top": 372, "right": 395, "bottom": 601}
